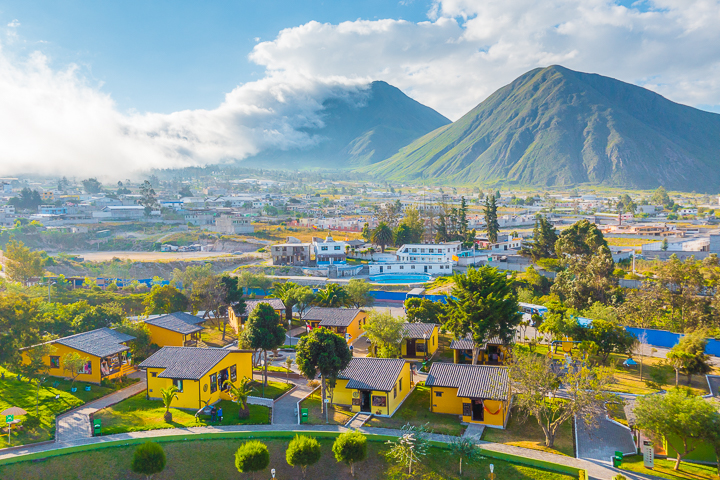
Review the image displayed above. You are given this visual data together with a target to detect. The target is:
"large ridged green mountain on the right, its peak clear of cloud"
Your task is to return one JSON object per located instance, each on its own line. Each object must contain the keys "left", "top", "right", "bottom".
{"left": 361, "top": 66, "right": 720, "bottom": 192}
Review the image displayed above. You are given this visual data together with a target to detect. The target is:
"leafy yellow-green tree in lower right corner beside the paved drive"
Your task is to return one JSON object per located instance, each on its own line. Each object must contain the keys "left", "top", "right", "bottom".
{"left": 633, "top": 389, "right": 717, "bottom": 470}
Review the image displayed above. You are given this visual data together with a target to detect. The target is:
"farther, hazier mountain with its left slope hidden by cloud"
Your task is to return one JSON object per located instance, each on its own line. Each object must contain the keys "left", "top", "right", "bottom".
{"left": 248, "top": 82, "right": 450, "bottom": 169}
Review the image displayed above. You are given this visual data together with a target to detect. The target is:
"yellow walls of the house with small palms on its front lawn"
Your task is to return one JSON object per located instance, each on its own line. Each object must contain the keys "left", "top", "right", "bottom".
{"left": 146, "top": 351, "right": 252, "bottom": 410}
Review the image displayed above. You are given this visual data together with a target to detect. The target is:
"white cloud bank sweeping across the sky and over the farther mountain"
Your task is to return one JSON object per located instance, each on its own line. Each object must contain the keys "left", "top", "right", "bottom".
{"left": 0, "top": 0, "right": 720, "bottom": 177}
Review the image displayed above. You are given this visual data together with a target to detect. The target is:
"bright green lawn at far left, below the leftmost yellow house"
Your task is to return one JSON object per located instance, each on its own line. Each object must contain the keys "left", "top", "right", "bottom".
{"left": 0, "top": 368, "right": 119, "bottom": 448}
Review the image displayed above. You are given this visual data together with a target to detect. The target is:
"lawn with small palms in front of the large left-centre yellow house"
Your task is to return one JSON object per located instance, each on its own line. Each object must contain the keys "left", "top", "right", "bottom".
{"left": 95, "top": 392, "right": 270, "bottom": 435}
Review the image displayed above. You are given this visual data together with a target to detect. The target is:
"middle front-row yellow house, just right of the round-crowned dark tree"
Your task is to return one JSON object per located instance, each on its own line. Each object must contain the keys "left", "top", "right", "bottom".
{"left": 332, "top": 357, "right": 413, "bottom": 417}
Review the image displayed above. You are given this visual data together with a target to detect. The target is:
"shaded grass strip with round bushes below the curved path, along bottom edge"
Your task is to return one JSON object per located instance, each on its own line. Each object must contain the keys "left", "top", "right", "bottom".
{"left": 0, "top": 439, "right": 573, "bottom": 480}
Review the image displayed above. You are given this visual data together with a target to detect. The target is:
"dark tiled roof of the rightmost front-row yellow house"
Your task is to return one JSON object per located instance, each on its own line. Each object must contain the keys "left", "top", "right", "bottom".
{"left": 425, "top": 362, "right": 508, "bottom": 400}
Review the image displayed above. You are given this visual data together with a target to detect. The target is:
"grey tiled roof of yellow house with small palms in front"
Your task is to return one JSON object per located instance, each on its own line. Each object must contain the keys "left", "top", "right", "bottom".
{"left": 139, "top": 347, "right": 238, "bottom": 380}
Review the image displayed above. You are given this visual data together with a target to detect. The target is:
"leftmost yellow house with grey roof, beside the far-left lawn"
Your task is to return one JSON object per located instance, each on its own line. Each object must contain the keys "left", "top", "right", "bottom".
{"left": 22, "top": 328, "right": 136, "bottom": 384}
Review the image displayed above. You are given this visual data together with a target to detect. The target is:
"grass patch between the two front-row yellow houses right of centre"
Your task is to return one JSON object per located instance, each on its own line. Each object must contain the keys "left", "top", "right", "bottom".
{"left": 365, "top": 382, "right": 465, "bottom": 436}
